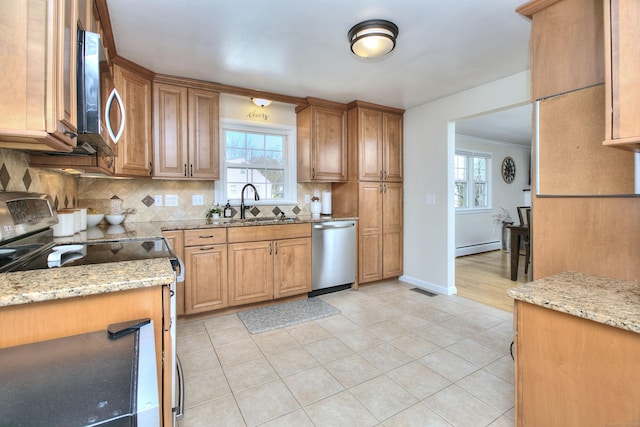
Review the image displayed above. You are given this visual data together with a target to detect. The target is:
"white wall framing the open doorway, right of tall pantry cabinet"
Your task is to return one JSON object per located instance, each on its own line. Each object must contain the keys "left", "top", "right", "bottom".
{"left": 401, "top": 71, "right": 530, "bottom": 294}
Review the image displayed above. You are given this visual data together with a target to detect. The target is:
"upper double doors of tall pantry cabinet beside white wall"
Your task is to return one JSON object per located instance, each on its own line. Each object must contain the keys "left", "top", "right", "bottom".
{"left": 349, "top": 101, "right": 403, "bottom": 182}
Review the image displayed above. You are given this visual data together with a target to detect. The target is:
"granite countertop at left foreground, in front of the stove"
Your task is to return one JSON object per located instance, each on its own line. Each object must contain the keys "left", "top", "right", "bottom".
{"left": 0, "top": 258, "right": 175, "bottom": 307}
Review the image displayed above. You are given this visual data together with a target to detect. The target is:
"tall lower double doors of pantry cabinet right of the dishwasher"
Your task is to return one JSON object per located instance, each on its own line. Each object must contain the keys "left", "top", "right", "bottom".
{"left": 358, "top": 182, "right": 403, "bottom": 283}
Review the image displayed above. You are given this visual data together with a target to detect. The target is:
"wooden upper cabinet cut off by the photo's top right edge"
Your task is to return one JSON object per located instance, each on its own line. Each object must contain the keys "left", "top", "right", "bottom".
{"left": 604, "top": 0, "right": 640, "bottom": 151}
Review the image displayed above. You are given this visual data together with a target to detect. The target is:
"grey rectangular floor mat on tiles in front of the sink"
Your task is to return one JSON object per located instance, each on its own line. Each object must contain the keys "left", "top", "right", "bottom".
{"left": 238, "top": 298, "right": 340, "bottom": 334}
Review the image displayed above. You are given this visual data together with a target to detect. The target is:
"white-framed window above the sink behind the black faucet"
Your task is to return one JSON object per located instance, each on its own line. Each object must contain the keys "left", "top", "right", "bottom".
{"left": 216, "top": 120, "right": 296, "bottom": 205}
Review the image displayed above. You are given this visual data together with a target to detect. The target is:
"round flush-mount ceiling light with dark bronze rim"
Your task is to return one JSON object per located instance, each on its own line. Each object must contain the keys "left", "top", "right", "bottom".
{"left": 349, "top": 19, "right": 398, "bottom": 58}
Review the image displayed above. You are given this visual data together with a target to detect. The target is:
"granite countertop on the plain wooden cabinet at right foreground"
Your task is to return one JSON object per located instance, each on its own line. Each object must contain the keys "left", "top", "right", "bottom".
{"left": 507, "top": 272, "right": 640, "bottom": 333}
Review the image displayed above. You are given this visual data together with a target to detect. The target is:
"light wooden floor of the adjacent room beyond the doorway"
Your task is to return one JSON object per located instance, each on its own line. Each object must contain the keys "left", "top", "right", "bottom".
{"left": 456, "top": 250, "right": 531, "bottom": 311}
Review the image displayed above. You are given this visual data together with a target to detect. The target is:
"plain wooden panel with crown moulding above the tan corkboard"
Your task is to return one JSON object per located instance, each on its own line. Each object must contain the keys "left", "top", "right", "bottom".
{"left": 517, "top": 0, "right": 605, "bottom": 101}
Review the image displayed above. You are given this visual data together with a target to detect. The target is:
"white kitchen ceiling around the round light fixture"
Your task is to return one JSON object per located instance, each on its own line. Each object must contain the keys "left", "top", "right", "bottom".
{"left": 107, "top": 0, "right": 531, "bottom": 143}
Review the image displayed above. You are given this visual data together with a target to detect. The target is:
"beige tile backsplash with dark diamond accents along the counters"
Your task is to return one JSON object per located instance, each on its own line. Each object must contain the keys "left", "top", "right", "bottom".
{"left": 0, "top": 149, "right": 331, "bottom": 222}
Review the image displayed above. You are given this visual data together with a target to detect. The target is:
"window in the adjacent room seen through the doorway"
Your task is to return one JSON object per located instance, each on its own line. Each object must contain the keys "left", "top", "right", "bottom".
{"left": 453, "top": 150, "right": 491, "bottom": 209}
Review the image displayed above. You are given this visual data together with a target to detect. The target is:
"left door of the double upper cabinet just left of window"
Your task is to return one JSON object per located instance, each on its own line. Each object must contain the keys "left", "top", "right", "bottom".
{"left": 153, "top": 83, "right": 188, "bottom": 178}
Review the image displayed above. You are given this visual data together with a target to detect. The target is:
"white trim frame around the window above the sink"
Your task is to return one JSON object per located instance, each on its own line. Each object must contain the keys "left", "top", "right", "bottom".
{"left": 214, "top": 117, "right": 298, "bottom": 206}
